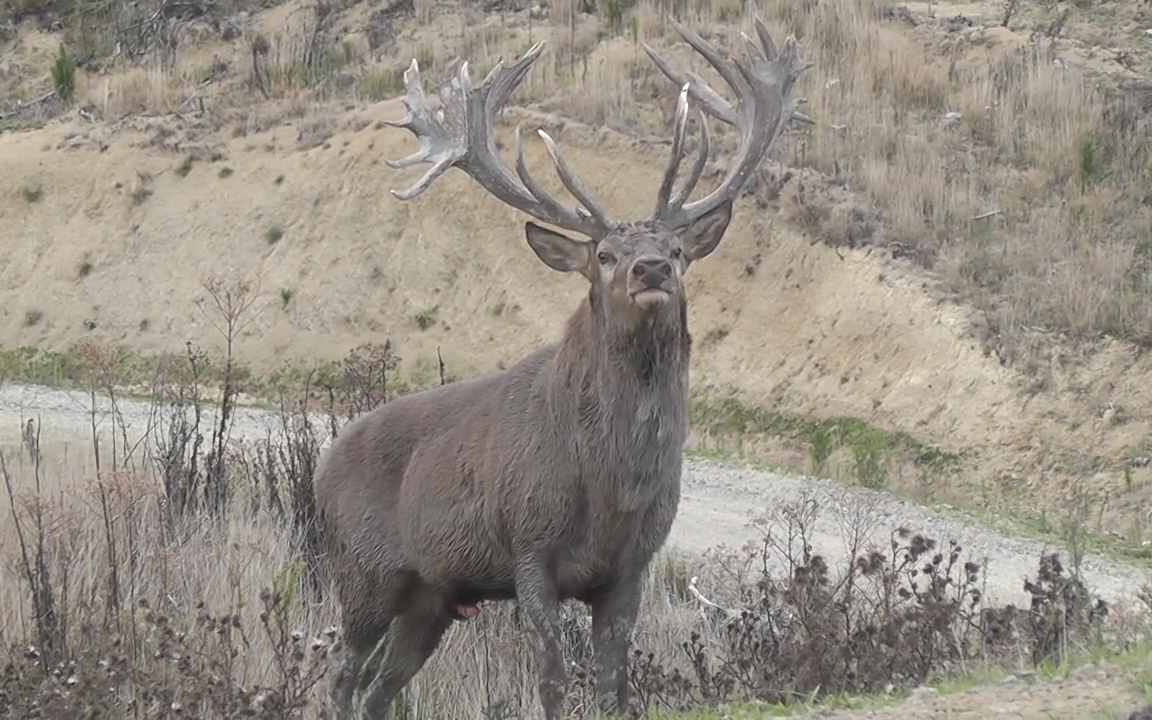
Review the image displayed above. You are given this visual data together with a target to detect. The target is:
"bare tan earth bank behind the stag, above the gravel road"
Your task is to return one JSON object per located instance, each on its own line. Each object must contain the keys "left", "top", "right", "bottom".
{"left": 0, "top": 3, "right": 1152, "bottom": 545}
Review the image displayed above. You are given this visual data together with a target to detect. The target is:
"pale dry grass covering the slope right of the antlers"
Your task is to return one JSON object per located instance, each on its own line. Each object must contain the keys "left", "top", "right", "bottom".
{"left": 728, "top": 0, "right": 1152, "bottom": 362}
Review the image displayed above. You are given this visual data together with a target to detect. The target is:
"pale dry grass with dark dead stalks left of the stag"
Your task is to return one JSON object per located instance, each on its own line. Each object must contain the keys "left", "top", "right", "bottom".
{"left": 0, "top": 359, "right": 333, "bottom": 718}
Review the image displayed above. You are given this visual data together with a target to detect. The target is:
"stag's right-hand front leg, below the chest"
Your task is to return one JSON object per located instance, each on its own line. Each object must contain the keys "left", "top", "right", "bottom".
{"left": 590, "top": 577, "right": 641, "bottom": 712}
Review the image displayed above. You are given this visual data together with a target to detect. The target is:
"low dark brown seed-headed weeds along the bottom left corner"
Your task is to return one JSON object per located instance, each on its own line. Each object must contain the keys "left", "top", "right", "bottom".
{"left": 0, "top": 564, "right": 331, "bottom": 719}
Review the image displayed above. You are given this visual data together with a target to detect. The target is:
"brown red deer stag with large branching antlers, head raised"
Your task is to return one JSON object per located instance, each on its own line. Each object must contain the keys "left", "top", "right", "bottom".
{"left": 316, "top": 20, "right": 810, "bottom": 720}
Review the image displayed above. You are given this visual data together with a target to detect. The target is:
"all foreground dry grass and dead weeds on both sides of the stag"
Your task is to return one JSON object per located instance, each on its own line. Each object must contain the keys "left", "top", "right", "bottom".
{"left": 0, "top": 334, "right": 1138, "bottom": 718}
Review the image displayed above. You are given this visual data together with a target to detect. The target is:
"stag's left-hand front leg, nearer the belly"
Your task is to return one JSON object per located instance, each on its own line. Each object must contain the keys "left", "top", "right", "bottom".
{"left": 516, "top": 563, "right": 568, "bottom": 720}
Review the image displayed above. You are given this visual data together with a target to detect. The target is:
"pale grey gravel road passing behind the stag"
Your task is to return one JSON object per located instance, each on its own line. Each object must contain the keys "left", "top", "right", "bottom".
{"left": 0, "top": 385, "right": 1152, "bottom": 606}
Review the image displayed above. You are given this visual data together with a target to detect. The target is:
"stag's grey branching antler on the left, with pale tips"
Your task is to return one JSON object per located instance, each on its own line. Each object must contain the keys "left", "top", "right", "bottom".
{"left": 385, "top": 43, "right": 613, "bottom": 240}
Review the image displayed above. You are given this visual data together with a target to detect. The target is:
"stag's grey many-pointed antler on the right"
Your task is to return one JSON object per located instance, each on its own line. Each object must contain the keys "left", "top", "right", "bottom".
{"left": 644, "top": 17, "right": 812, "bottom": 227}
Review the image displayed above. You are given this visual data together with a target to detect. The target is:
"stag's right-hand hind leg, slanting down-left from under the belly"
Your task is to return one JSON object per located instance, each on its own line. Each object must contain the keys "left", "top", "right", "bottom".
{"left": 364, "top": 588, "right": 452, "bottom": 720}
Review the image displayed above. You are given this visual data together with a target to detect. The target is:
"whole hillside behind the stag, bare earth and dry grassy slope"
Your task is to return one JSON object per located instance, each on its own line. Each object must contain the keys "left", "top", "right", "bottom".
{"left": 0, "top": 0, "right": 1152, "bottom": 548}
